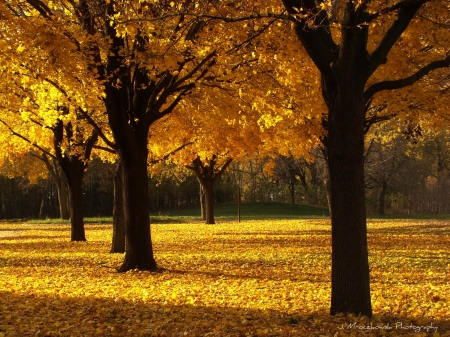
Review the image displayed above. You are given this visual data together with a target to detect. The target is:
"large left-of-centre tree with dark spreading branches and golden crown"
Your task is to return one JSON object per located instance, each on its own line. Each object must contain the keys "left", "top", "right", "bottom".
{"left": 2, "top": 0, "right": 292, "bottom": 271}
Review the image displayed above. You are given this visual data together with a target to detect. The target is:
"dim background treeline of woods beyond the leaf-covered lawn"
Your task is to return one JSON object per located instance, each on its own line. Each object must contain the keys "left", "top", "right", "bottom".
{"left": 0, "top": 133, "right": 450, "bottom": 219}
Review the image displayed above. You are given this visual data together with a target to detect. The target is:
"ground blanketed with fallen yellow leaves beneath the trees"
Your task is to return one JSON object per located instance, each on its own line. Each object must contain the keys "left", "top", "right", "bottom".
{"left": 0, "top": 220, "right": 450, "bottom": 337}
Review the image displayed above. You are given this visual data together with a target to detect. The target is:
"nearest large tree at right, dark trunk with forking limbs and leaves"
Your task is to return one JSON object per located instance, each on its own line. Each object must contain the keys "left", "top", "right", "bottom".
{"left": 283, "top": 0, "right": 450, "bottom": 316}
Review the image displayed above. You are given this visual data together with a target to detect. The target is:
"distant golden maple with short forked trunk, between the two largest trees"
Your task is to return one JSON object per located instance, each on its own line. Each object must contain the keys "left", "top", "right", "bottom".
{"left": 146, "top": 23, "right": 323, "bottom": 224}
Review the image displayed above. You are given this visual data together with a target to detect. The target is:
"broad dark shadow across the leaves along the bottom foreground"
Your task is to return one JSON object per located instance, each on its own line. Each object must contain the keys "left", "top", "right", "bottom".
{"left": 0, "top": 292, "right": 450, "bottom": 337}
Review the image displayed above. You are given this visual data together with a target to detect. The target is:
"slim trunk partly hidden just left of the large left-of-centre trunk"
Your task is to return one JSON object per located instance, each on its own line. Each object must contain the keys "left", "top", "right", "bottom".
{"left": 110, "top": 160, "right": 125, "bottom": 253}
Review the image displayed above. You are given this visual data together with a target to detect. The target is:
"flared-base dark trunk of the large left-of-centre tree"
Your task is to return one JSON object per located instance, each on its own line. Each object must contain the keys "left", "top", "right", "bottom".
{"left": 119, "top": 148, "right": 157, "bottom": 272}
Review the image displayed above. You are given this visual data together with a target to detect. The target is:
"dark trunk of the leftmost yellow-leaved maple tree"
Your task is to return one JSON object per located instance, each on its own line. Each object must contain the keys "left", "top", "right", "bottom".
{"left": 66, "top": 158, "right": 86, "bottom": 241}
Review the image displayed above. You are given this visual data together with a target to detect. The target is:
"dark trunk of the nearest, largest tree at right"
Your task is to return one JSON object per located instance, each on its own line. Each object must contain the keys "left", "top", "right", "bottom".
{"left": 324, "top": 73, "right": 372, "bottom": 316}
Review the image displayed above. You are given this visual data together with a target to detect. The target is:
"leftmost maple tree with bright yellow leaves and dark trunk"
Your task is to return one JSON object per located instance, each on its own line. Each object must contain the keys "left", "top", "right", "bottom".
{"left": 0, "top": 57, "right": 98, "bottom": 241}
